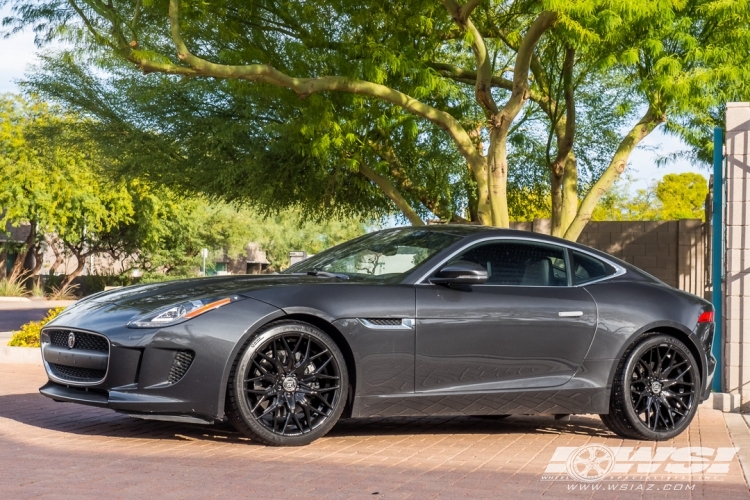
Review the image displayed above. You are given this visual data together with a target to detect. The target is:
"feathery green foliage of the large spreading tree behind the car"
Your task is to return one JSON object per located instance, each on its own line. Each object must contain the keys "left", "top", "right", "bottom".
{"left": 0, "top": 0, "right": 750, "bottom": 234}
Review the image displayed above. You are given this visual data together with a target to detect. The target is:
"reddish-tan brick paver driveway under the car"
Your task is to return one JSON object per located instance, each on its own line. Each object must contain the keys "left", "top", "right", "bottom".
{"left": 0, "top": 365, "right": 750, "bottom": 500}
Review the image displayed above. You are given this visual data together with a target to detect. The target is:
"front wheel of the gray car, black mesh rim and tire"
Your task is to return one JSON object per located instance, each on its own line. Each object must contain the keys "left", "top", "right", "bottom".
{"left": 226, "top": 321, "right": 349, "bottom": 446}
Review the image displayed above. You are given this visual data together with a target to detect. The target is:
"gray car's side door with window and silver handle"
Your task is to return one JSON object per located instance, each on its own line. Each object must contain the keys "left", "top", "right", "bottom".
{"left": 415, "top": 239, "right": 597, "bottom": 392}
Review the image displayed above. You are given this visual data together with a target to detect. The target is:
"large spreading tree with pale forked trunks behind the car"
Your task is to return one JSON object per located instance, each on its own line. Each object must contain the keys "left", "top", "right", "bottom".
{"left": 8, "top": 0, "right": 750, "bottom": 239}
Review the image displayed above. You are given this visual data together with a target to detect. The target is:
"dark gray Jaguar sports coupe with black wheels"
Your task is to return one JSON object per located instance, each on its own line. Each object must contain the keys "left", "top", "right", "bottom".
{"left": 36, "top": 225, "right": 716, "bottom": 445}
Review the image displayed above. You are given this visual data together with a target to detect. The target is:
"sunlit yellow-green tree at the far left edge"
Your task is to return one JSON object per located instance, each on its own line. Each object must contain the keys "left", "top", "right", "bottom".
{"left": 0, "top": 96, "right": 164, "bottom": 285}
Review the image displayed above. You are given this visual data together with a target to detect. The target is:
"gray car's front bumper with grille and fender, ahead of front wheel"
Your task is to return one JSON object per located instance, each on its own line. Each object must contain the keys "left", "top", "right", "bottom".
{"left": 40, "top": 299, "right": 284, "bottom": 423}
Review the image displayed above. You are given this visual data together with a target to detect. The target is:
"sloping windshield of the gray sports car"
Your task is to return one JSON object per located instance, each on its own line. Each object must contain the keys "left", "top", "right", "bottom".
{"left": 282, "top": 229, "right": 464, "bottom": 281}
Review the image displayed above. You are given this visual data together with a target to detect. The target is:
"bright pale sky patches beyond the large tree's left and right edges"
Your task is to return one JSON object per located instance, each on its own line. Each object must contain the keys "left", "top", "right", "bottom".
{"left": 0, "top": 8, "right": 709, "bottom": 194}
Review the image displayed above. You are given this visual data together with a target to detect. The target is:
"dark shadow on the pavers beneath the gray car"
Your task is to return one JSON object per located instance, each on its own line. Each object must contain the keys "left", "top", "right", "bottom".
{"left": 0, "top": 393, "right": 614, "bottom": 443}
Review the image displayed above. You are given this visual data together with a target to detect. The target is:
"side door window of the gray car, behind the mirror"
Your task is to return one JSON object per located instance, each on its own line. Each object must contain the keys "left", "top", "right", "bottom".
{"left": 453, "top": 241, "right": 568, "bottom": 286}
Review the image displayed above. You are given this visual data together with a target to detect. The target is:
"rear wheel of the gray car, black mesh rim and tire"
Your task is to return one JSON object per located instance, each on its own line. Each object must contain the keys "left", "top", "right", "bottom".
{"left": 600, "top": 334, "right": 701, "bottom": 441}
